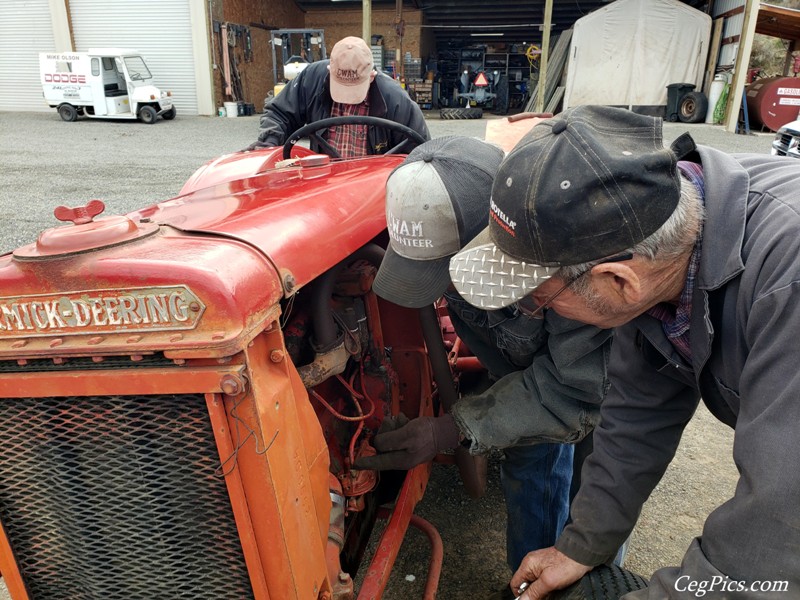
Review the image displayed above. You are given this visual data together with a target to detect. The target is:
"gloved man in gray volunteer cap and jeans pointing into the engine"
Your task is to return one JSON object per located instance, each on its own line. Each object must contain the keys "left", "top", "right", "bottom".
{"left": 356, "top": 137, "right": 611, "bottom": 570}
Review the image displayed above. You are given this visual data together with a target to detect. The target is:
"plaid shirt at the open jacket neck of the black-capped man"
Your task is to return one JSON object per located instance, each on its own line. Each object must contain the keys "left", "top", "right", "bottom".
{"left": 647, "top": 161, "right": 705, "bottom": 363}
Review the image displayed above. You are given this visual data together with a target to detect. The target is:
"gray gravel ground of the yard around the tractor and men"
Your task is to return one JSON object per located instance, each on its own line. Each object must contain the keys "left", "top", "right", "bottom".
{"left": 0, "top": 111, "right": 773, "bottom": 600}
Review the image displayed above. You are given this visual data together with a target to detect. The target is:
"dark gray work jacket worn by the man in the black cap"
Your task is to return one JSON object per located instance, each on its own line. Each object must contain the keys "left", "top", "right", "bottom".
{"left": 556, "top": 147, "right": 800, "bottom": 600}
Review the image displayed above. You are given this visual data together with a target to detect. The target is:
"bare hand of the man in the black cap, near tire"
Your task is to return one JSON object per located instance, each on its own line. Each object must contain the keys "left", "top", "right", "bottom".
{"left": 510, "top": 546, "right": 592, "bottom": 600}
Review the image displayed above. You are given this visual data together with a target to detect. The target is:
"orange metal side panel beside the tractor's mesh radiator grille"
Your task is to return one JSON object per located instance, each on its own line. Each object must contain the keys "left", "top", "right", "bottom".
{"left": 238, "top": 327, "right": 338, "bottom": 600}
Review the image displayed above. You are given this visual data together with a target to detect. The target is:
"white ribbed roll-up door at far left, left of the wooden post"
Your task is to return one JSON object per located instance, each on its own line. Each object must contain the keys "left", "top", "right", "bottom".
{"left": 0, "top": 0, "right": 56, "bottom": 111}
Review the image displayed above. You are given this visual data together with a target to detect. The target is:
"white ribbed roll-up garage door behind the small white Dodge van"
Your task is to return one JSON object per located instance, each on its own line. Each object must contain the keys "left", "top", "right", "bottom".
{"left": 69, "top": 0, "right": 197, "bottom": 115}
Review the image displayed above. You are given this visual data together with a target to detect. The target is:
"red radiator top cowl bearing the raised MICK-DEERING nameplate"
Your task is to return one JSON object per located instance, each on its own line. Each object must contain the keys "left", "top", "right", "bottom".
{"left": 0, "top": 230, "right": 282, "bottom": 359}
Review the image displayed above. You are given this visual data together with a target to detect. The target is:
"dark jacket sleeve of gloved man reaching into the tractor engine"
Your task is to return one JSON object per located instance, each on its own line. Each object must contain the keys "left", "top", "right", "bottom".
{"left": 452, "top": 310, "right": 612, "bottom": 454}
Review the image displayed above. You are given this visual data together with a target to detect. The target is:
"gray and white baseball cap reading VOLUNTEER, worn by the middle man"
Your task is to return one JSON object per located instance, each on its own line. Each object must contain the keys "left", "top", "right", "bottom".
{"left": 372, "top": 136, "right": 503, "bottom": 308}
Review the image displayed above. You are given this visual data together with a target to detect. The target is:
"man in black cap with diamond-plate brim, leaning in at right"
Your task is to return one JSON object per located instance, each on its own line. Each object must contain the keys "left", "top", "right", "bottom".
{"left": 450, "top": 106, "right": 800, "bottom": 600}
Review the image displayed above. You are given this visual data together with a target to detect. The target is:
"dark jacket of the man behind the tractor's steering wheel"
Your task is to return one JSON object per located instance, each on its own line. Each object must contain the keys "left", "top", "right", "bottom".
{"left": 257, "top": 60, "right": 431, "bottom": 154}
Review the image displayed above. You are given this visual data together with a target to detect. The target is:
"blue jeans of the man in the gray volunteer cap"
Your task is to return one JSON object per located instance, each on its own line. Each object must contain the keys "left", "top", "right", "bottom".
{"left": 500, "top": 444, "right": 574, "bottom": 571}
